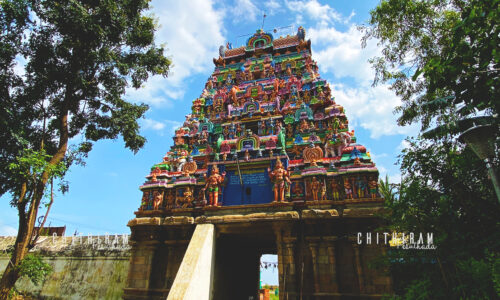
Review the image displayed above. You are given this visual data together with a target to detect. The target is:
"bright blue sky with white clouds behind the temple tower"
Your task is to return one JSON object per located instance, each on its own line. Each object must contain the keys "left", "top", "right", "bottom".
{"left": 0, "top": 0, "right": 417, "bottom": 284}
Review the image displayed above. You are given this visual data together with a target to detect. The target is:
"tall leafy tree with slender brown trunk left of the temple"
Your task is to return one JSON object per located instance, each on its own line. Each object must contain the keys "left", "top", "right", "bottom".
{"left": 0, "top": 0, "right": 170, "bottom": 299}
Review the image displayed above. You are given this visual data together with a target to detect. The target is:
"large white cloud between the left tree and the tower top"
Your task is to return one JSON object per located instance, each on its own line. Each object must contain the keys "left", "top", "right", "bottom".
{"left": 127, "top": 0, "right": 225, "bottom": 107}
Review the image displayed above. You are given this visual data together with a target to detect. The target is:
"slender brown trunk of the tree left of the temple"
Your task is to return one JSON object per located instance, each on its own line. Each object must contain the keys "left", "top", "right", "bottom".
{"left": 0, "top": 110, "right": 69, "bottom": 300}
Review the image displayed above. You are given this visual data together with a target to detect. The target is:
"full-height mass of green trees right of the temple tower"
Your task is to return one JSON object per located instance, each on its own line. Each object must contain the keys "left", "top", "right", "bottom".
{"left": 362, "top": 0, "right": 500, "bottom": 299}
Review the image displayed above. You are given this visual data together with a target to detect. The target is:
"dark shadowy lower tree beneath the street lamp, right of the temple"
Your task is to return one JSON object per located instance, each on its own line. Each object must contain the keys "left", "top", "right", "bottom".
{"left": 381, "top": 139, "right": 500, "bottom": 299}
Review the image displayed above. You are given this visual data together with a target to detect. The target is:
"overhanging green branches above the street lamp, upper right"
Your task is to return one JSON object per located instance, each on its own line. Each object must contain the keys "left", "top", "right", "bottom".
{"left": 362, "top": 0, "right": 500, "bottom": 137}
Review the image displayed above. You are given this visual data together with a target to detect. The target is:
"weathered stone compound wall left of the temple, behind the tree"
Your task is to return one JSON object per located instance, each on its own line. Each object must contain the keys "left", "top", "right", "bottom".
{"left": 0, "top": 235, "right": 130, "bottom": 300}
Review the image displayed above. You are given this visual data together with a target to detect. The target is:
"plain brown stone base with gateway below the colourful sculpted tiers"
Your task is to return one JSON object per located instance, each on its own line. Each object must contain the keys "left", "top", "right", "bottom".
{"left": 123, "top": 199, "right": 392, "bottom": 300}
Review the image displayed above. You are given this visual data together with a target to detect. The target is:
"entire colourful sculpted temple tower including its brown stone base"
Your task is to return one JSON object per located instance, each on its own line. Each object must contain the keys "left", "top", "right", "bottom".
{"left": 124, "top": 27, "right": 391, "bottom": 300}
